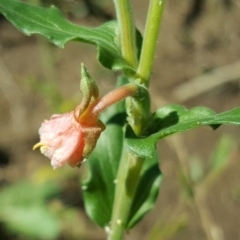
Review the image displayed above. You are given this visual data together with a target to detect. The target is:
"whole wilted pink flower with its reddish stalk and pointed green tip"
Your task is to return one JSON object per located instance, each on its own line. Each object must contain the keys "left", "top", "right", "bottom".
{"left": 33, "top": 73, "right": 137, "bottom": 169}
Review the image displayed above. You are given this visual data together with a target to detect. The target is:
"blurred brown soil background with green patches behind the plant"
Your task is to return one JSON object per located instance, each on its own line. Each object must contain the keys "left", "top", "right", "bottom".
{"left": 0, "top": 0, "right": 240, "bottom": 240}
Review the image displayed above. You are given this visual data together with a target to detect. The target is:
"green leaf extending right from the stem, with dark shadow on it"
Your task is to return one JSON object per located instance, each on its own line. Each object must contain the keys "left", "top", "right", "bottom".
{"left": 126, "top": 105, "right": 240, "bottom": 157}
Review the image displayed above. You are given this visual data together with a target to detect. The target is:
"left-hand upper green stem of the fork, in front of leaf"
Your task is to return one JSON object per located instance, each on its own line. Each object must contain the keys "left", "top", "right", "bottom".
{"left": 114, "top": 0, "right": 137, "bottom": 68}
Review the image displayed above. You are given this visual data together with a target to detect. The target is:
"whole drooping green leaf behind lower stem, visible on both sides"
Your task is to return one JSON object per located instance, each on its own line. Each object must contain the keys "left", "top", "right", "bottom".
{"left": 82, "top": 77, "right": 162, "bottom": 228}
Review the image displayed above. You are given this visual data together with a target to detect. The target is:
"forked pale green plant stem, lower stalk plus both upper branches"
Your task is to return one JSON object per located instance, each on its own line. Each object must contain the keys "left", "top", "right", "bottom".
{"left": 108, "top": 0, "right": 164, "bottom": 240}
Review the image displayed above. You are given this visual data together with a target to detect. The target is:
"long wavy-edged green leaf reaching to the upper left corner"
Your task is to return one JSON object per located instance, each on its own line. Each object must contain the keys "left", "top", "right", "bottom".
{"left": 0, "top": 0, "right": 133, "bottom": 71}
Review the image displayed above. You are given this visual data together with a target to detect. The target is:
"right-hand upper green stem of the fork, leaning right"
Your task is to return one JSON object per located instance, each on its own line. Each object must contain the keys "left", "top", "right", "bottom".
{"left": 137, "top": 0, "right": 165, "bottom": 85}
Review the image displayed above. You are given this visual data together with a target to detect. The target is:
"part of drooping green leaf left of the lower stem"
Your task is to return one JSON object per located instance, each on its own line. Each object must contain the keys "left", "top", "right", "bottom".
{"left": 82, "top": 100, "right": 126, "bottom": 227}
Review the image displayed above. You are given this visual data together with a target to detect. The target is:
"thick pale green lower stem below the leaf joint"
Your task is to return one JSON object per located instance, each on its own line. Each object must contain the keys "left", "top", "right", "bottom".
{"left": 108, "top": 150, "right": 144, "bottom": 240}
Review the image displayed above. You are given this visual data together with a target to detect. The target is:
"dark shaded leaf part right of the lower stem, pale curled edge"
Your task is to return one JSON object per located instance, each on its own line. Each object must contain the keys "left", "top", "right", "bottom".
{"left": 128, "top": 154, "right": 163, "bottom": 229}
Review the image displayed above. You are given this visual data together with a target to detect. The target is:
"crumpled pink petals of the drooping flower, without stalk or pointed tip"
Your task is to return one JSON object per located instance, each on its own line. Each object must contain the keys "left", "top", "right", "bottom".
{"left": 33, "top": 111, "right": 103, "bottom": 169}
